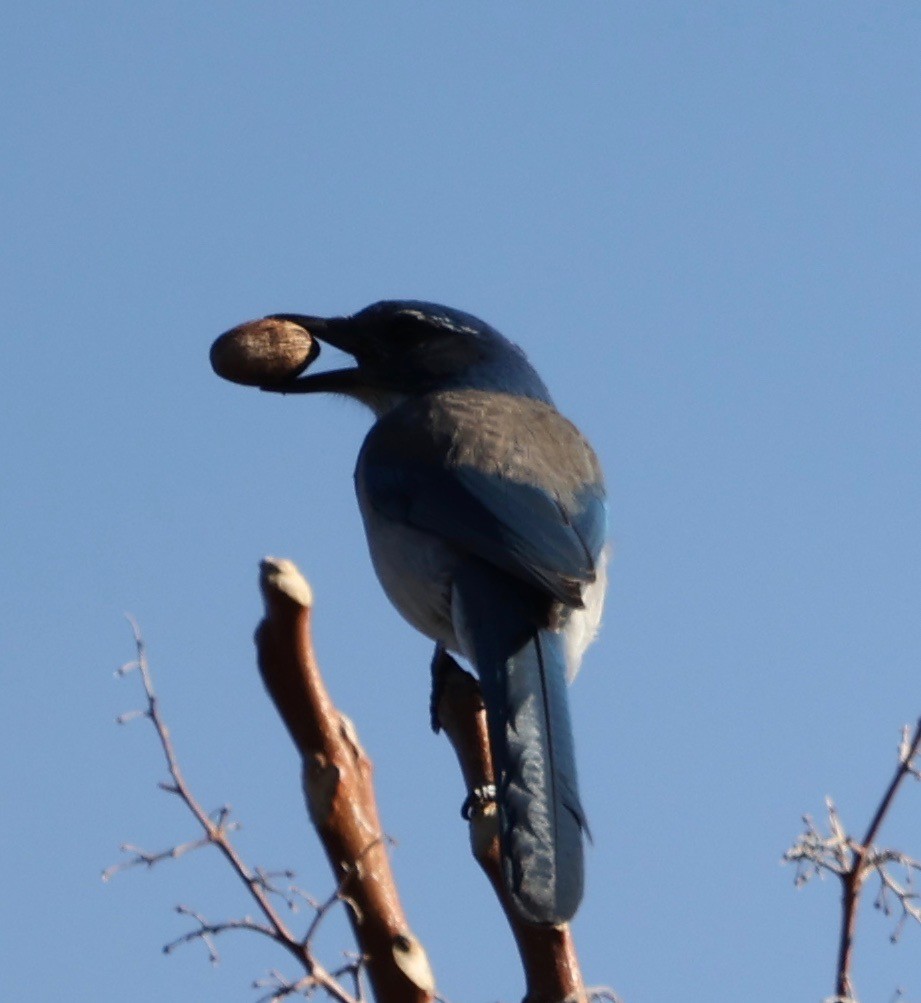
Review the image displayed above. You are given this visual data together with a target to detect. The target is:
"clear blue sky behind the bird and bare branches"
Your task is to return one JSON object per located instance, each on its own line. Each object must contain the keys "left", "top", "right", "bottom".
{"left": 0, "top": 2, "right": 921, "bottom": 1003}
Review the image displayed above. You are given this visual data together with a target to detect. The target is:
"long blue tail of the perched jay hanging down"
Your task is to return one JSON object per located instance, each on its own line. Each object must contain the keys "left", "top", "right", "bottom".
{"left": 454, "top": 566, "right": 585, "bottom": 925}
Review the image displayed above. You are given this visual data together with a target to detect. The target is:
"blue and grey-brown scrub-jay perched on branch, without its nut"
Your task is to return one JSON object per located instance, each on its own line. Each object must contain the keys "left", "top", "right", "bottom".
{"left": 265, "top": 300, "right": 606, "bottom": 924}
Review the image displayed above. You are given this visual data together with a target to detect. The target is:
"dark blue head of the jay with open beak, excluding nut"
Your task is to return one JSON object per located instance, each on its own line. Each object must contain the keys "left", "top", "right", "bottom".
{"left": 267, "top": 300, "right": 550, "bottom": 414}
